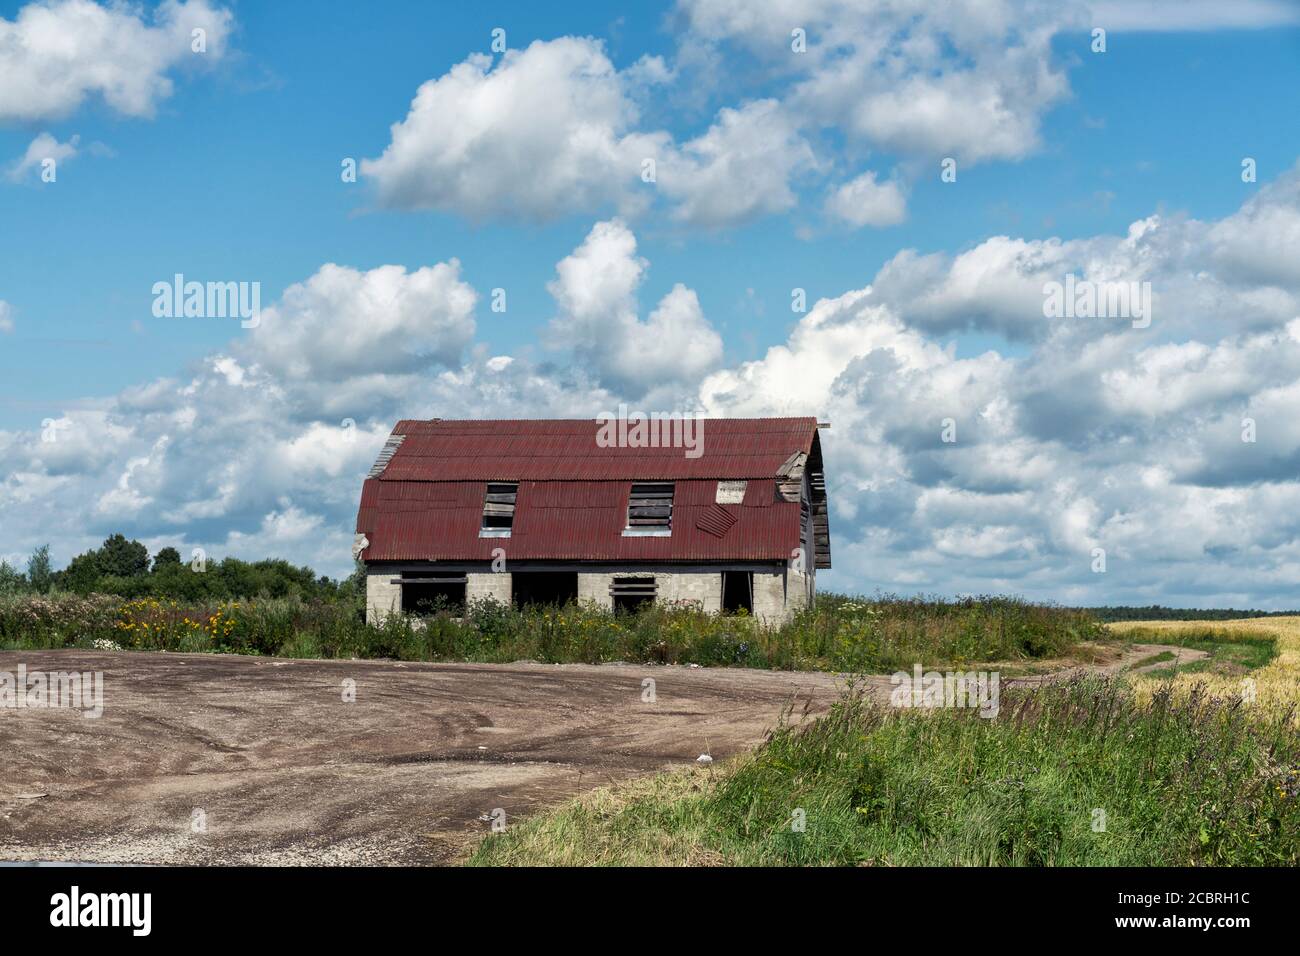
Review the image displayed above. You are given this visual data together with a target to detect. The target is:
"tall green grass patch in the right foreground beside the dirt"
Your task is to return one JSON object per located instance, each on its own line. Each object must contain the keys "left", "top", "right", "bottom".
{"left": 468, "top": 678, "right": 1300, "bottom": 866}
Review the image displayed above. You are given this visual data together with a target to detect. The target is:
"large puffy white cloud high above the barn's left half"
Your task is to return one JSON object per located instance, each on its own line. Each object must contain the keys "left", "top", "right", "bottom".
{"left": 361, "top": 36, "right": 666, "bottom": 220}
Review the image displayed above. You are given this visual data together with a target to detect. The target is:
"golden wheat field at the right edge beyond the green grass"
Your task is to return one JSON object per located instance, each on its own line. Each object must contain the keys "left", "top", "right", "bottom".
{"left": 1109, "top": 617, "right": 1300, "bottom": 726}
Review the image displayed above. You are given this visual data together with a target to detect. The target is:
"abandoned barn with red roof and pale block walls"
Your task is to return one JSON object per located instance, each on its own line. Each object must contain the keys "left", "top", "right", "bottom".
{"left": 354, "top": 418, "right": 831, "bottom": 622}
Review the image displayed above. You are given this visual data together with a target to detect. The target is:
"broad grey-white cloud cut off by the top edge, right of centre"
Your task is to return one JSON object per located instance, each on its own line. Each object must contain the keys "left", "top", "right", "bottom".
{"left": 679, "top": 0, "right": 1087, "bottom": 161}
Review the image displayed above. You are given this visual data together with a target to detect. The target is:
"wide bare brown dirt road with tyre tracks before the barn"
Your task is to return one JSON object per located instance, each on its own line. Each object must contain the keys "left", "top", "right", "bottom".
{"left": 0, "top": 650, "right": 839, "bottom": 864}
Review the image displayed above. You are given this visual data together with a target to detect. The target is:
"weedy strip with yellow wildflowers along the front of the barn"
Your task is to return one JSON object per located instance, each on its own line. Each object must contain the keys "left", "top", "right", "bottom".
{"left": 0, "top": 594, "right": 1104, "bottom": 672}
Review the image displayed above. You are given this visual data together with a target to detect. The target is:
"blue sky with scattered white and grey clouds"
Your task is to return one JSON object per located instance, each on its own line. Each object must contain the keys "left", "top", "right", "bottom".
{"left": 0, "top": 0, "right": 1300, "bottom": 607}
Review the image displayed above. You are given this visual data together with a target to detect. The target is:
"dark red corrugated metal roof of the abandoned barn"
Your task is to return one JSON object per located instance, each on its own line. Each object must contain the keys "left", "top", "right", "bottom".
{"left": 356, "top": 419, "right": 816, "bottom": 562}
